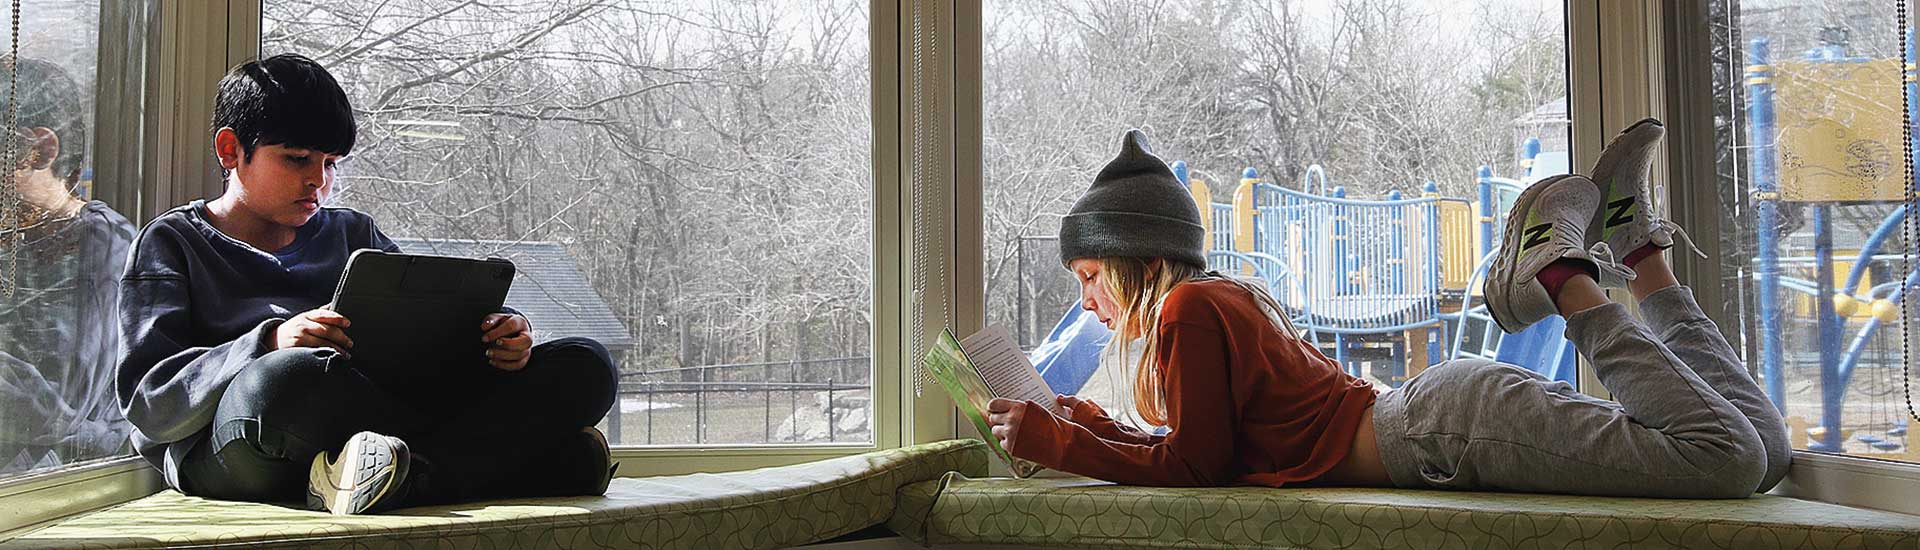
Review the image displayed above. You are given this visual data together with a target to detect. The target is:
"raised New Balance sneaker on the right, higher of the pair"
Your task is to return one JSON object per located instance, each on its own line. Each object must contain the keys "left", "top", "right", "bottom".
{"left": 1586, "top": 119, "right": 1699, "bottom": 288}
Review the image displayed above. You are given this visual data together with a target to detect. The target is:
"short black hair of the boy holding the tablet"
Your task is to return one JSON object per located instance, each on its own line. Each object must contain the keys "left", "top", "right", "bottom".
{"left": 213, "top": 54, "right": 353, "bottom": 158}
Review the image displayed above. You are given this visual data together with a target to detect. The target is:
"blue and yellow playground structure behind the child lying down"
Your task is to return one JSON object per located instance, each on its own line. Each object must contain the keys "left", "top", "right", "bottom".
{"left": 1173, "top": 145, "right": 1574, "bottom": 387}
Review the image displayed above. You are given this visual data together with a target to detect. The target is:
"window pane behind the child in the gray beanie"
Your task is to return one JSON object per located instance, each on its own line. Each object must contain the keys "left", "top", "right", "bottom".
{"left": 983, "top": 0, "right": 1576, "bottom": 428}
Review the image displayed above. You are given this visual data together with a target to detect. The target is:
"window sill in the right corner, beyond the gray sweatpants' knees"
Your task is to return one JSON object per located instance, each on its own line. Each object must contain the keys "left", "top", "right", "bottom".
{"left": 1772, "top": 450, "right": 1920, "bottom": 515}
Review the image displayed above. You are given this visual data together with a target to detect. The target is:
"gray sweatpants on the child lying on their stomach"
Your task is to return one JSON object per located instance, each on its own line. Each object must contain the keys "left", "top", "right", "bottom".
{"left": 1373, "top": 287, "right": 1791, "bottom": 498}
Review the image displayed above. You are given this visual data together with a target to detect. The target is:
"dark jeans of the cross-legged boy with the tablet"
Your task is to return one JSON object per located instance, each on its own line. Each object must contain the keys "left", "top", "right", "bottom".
{"left": 179, "top": 338, "right": 618, "bottom": 504}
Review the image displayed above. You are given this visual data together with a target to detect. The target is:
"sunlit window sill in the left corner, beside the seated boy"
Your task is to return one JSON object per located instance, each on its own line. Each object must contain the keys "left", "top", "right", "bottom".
{"left": 0, "top": 456, "right": 165, "bottom": 540}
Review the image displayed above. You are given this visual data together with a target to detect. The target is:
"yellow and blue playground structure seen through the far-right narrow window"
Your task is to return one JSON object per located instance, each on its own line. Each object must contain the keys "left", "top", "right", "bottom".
{"left": 1745, "top": 33, "right": 1920, "bottom": 460}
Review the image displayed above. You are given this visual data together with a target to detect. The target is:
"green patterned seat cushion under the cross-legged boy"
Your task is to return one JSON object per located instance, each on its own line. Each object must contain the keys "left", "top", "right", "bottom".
{"left": 0, "top": 440, "right": 987, "bottom": 550}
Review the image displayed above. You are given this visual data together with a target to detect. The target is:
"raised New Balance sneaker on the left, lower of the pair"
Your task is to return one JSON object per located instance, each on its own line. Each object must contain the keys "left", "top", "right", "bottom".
{"left": 1482, "top": 175, "right": 1632, "bottom": 333}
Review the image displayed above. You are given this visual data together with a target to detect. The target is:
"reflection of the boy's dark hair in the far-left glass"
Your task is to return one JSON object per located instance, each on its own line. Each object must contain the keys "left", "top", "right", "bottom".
{"left": 0, "top": 58, "right": 92, "bottom": 183}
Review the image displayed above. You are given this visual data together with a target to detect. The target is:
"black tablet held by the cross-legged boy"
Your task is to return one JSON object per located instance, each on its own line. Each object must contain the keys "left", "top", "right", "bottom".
{"left": 334, "top": 248, "right": 513, "bottom": 381}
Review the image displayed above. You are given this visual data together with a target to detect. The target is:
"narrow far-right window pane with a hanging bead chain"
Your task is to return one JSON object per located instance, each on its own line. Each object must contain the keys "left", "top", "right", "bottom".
{"left": 1707, "top": 0, "right": 1920, "bottom": 462}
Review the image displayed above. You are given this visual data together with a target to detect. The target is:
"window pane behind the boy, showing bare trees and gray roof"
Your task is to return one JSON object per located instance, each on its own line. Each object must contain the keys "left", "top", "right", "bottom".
{"left": 261, "top": 0, "right": 874, "bottom": 446}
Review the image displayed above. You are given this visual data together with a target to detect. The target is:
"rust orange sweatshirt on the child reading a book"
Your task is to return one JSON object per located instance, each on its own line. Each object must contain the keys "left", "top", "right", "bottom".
{"left": 1012, "top": 279, "right": 1375, "bottom": 487}
